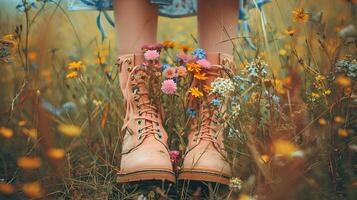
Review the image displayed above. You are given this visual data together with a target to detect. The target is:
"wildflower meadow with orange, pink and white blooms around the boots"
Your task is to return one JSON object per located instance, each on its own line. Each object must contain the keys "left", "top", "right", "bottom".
{"left": 0, "top": 0, "right": 357, "bottom": 200}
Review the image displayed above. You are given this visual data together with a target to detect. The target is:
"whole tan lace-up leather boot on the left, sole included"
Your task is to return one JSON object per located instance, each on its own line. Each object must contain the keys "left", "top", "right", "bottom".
{"left": 117, "top": 54, "right": 175, "bottom": 183}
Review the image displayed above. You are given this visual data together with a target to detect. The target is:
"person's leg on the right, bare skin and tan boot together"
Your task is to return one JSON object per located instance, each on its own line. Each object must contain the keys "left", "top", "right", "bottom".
{"left": 178, "top": 0, "right": 238, "bottom": 185}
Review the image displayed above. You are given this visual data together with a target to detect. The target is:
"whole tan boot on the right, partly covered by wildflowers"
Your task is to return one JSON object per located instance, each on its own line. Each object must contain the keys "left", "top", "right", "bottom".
{"left": 178, "top": 53, "right": 234, "bottom": 185}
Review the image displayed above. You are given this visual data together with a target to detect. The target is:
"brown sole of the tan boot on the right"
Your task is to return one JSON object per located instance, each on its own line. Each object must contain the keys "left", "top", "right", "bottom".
{"left": 178, "top": 170, "right": 230, "bottom": 185}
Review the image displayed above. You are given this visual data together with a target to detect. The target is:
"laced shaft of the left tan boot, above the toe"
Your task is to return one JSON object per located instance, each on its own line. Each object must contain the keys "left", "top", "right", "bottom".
{"left": 118, "top": 54, "right": 168, "bottom": 152}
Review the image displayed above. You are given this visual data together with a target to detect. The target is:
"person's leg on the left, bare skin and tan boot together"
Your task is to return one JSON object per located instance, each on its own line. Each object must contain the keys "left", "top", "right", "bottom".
{"left": 113, "top": 0, "right": 176, "bottom": 183}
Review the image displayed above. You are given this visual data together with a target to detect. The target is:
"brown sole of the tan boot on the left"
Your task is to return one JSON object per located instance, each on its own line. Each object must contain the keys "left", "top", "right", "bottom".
{"left": 117, "top": 170, "right": 176, "bottom": 183}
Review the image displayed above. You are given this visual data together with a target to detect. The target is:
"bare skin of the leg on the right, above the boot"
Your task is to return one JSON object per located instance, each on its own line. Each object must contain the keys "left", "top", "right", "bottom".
{"left": 198, "top": 0, "right": 238, "bottom": 54}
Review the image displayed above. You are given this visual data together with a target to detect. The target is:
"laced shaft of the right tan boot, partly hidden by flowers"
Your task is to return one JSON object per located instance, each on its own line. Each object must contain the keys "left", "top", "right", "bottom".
{"left": 188, "top": 53, "right": 235, "bottom": 149}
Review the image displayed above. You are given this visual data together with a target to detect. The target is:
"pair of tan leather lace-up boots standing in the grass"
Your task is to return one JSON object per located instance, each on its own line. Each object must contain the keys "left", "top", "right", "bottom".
{"left": 117, "top": 53, "right": 234, "bottom": 184}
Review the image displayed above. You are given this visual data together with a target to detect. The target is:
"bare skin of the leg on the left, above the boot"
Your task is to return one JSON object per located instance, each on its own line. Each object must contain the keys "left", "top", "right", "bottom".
{"left": 114, "top": 0, "right": 158, "bottom": 55}
